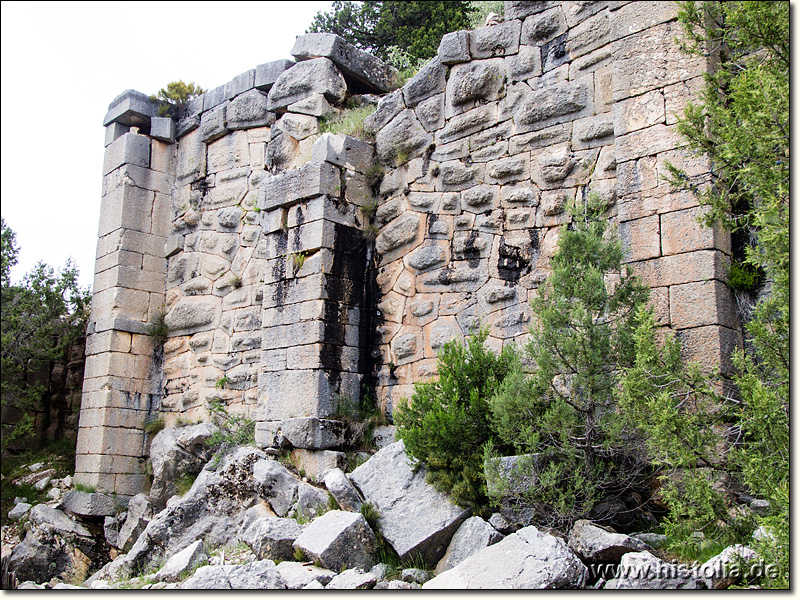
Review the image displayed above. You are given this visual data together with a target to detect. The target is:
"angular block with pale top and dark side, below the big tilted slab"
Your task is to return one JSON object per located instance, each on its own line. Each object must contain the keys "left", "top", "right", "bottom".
{"left": 294, "top": 510, "right": 378, "bottom": 572}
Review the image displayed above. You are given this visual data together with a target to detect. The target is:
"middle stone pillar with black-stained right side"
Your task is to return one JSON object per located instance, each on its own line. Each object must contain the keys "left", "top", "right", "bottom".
{"left": 256, "top": 135, "right": 373, "bottom": 450}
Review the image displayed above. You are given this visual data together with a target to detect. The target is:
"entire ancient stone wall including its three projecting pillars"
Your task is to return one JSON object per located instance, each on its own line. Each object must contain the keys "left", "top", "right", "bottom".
{"left": 77, "top": 2, "right": 739, "bottom": 494}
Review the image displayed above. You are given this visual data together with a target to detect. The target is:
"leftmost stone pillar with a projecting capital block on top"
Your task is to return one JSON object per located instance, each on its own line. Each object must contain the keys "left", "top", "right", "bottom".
{"left": 75, "top": 91, "right": 174, "bottom": 496}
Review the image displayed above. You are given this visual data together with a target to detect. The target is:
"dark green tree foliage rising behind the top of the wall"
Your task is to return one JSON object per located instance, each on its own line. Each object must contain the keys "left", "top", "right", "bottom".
{"left": 307, "top": 0, "right": 474, "bottom": 63}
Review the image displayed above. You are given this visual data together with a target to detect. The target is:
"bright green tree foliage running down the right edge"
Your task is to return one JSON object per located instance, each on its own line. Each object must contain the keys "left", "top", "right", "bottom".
{"left": 644, "top": 2, "right": 790, "bottom": 585}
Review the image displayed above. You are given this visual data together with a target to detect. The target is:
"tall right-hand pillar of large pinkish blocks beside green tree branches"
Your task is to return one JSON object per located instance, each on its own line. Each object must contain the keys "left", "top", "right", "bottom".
{"left": 612, "top": 2, "right": 740, "bottom": 373}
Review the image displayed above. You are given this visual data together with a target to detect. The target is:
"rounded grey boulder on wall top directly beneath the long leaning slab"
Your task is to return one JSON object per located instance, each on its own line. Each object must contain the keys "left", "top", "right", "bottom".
{"left": 267, "top": 58, "right": 347, "bottom": 111}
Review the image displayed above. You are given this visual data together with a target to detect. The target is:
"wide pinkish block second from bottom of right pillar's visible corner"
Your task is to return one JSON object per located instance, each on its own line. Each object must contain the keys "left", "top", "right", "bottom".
{"left": 669, "top": 281, "right": 740, "bottom": 329}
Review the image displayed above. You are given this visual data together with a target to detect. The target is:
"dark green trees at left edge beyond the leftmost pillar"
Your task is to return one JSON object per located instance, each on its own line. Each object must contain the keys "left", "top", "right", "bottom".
{"left": 0, "top": 220, "right": 90, "bottom": 450}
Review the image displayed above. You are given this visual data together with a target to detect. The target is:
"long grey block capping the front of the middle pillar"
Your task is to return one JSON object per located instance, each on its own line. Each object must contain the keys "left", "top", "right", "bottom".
{"left": 257, "top": 162, "right": 341, "bottom": 210}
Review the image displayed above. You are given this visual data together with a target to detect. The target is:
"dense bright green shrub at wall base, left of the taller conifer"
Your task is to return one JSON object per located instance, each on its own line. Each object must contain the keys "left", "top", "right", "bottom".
{"left": 394, "top": 329, "right": 518, "bottom": 510}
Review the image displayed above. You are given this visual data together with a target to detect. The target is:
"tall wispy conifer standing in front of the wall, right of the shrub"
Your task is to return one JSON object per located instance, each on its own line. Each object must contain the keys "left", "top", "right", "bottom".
{"left": 490, "top": 198, "right": 647, "bottom": 525}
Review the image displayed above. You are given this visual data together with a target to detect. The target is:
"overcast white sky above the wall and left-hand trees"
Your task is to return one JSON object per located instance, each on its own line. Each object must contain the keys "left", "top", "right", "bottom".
{"left": 0, "top": 1, "right": 331, "bottom": 286}
